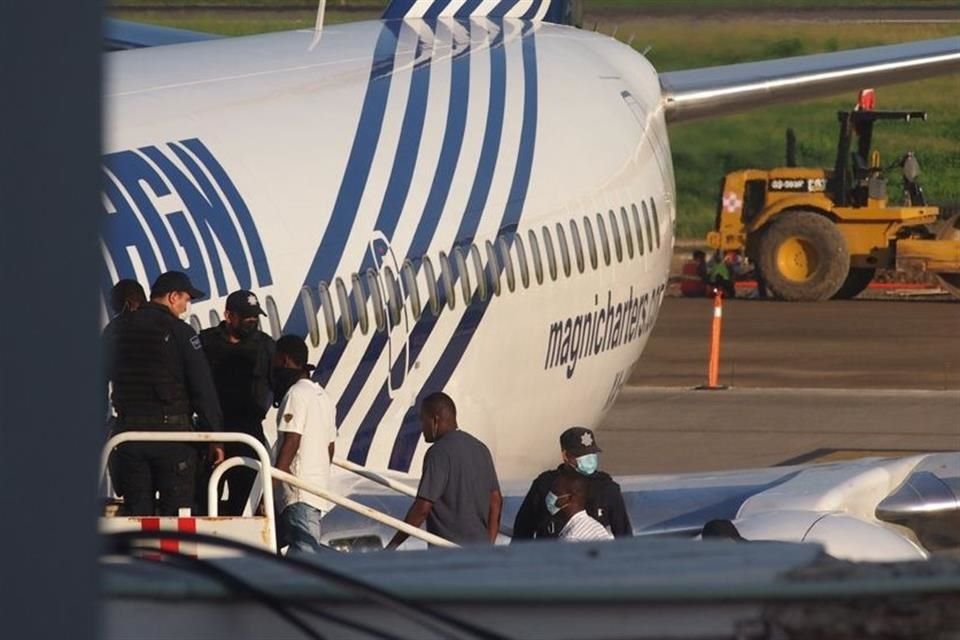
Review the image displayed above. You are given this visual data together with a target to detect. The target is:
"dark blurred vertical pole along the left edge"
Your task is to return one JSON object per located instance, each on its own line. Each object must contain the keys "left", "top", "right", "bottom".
{"left": 0, "top": 0, "right": 105, "bottom": 640}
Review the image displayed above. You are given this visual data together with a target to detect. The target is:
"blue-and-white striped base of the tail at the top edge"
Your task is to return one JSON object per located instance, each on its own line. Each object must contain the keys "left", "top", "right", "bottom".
{"left": 383, "top": 0, "right": 581, "bottom": 24}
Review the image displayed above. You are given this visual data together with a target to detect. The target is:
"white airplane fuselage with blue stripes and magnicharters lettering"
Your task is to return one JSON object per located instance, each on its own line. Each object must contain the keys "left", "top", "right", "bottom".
{"left": 101, "top": 19, "right": 675, "bottom": 478}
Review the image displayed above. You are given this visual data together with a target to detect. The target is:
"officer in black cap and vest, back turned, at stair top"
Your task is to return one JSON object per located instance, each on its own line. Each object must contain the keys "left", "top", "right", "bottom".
{"left": 107, "top": 271, "right": 223, "bottom": 516}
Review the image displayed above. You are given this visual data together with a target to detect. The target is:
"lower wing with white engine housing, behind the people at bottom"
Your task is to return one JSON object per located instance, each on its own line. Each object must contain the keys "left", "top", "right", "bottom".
{"left": 323, "top": 453, "right": 960, "bottom": 561}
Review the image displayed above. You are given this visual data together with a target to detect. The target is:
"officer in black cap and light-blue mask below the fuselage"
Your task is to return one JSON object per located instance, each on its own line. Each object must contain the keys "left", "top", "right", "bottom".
{"left": 513, "top": 427, "right": 633, "bottom": 540}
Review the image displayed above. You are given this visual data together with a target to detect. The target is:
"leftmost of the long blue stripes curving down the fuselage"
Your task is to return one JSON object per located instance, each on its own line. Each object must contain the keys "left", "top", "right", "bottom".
{"left": 283, "top": 22, "right": 401, "bottom": 336}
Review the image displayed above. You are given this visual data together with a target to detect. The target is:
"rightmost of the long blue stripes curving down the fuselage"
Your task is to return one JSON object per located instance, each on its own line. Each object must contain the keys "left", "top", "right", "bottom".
{"left": 389, "top": 22, "right": 539, "bottom": 471}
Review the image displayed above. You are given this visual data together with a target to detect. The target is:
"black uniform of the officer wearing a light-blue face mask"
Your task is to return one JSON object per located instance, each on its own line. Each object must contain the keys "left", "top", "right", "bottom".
{"left": 513, "top": 464, "right": 633, "bottom": 540}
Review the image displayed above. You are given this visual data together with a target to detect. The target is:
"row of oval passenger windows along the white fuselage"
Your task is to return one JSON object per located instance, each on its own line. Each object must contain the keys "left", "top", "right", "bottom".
{"left": 190, "top": 198, "right": 660, "bottom": 347}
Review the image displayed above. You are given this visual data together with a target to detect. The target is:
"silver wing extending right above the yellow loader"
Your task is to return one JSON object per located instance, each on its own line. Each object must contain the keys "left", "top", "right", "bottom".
{"left": 660, "top": 37, "right": 960, "bottom": 123}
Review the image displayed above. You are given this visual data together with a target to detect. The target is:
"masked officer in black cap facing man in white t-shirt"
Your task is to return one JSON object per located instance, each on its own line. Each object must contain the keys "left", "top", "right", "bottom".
{"left": 200, "top": 290, "right": 276, "bottom": 516}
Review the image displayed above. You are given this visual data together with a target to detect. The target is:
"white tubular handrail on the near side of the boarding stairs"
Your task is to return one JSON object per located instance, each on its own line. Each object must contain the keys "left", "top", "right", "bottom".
{"left": 100, "top": 431, "right": 459, "bottom": 549}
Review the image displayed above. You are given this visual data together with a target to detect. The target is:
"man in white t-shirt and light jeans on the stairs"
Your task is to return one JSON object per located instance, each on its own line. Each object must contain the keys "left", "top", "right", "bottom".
{"left": 273, "top": 335, "right": 337, "bottom": 553}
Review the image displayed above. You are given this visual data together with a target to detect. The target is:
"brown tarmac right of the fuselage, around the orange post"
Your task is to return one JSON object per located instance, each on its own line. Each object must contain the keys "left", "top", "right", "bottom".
{"left": 598, "top": 298, "right": 960, "bottom": 474}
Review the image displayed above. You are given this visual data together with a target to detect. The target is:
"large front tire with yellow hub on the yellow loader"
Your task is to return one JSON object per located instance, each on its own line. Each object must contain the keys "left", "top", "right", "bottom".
{"left": 757, "top": 210, "right": 850, "bottom": 302}
